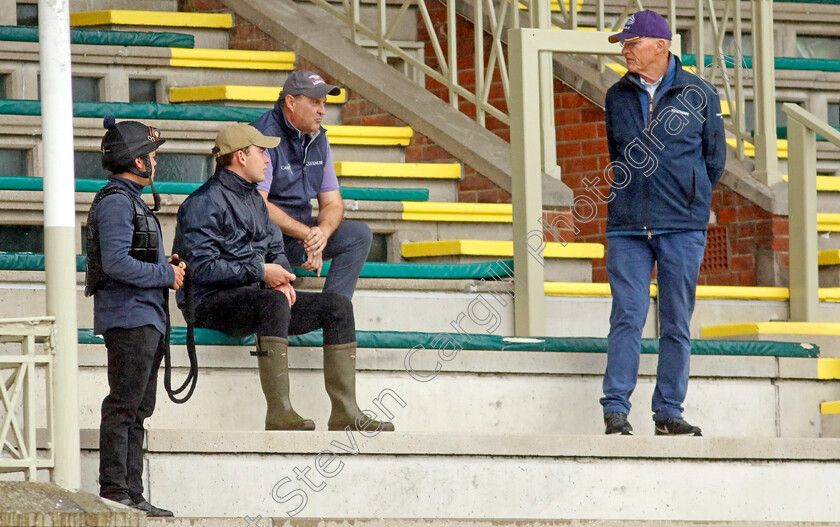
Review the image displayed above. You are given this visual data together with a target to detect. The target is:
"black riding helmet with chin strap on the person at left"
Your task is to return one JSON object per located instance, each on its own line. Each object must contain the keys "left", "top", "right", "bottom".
{"left": 101, "top": 115, "right": 166, "bottom": 211}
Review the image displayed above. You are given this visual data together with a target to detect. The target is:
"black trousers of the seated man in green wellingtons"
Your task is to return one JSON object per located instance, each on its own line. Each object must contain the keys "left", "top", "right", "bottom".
{"left": 195, "top": 287, "right": 356, "bottom": 344}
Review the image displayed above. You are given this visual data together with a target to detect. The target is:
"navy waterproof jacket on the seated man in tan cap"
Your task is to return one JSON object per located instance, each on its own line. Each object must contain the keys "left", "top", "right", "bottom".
{"left": 172, "top": 167, "right": 292, "bottom": 309}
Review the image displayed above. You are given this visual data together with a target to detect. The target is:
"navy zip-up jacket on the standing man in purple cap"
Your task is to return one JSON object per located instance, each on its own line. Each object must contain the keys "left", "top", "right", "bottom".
{"left": 606, "top": 56, "right": 726, "bottom": 233}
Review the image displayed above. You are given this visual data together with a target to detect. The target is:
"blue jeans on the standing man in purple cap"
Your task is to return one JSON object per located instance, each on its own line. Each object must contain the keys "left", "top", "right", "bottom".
{"left": 601, "top": 231, "right": 706, "bottom": 421}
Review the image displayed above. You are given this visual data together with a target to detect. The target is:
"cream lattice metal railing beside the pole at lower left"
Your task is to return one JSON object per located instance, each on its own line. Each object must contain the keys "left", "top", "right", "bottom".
{"left": 0, "top": 317, "right": 55, "bottom": 481}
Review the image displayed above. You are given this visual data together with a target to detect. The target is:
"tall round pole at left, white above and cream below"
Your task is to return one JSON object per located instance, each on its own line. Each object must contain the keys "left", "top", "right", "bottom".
{"left": 38, "top": 0, "right": 81, "bottom": 490}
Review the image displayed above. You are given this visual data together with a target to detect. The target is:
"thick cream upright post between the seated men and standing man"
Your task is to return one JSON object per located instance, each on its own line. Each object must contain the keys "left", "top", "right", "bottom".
{"left": 508, "top": 29, "right": 548, "bottom": 337}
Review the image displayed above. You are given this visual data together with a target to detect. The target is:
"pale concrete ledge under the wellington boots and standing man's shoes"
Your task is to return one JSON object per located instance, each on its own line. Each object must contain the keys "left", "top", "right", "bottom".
{"left": 118, "top": 430, "right": 840, "bottom": 461}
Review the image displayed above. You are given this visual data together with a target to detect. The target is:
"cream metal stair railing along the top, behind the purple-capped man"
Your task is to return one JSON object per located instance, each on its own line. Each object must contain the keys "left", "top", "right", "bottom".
{"left": 302, "top": 0, "right": 781, "bottom": 184}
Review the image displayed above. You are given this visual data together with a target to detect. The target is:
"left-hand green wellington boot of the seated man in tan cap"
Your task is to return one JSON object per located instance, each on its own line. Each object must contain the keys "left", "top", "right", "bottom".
{"left": 257, "top": 337, "right": 315, "bottom": 430}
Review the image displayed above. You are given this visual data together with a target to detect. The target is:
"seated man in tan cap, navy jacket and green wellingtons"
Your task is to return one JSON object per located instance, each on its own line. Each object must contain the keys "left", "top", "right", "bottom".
{"left": 173, "top": 125, "right": 394, "bottom": 431}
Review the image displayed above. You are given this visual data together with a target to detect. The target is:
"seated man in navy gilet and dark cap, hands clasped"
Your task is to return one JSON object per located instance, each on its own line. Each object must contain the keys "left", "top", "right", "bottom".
{"left": 251, "top": 70, "right": 373, "bottom": 298}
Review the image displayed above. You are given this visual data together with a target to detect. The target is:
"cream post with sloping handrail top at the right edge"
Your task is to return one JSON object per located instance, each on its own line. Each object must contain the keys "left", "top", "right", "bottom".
{"left": 782, "top": 103, "right": 840, "bottom": 322}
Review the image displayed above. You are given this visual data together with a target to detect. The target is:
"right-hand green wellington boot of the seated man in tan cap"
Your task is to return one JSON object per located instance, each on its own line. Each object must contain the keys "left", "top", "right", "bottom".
{"left": 324, "top": 342, "right": 394, "bottom": 432}
